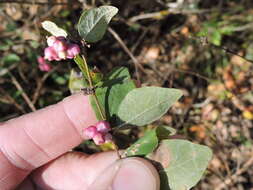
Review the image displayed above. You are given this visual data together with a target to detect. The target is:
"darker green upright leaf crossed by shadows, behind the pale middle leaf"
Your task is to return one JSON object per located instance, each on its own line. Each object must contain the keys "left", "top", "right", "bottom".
{"left": 90, "top": 67, "right": 135, "bottom": 121}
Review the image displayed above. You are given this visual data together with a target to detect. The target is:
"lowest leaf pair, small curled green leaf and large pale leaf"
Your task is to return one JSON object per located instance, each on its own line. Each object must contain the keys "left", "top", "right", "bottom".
{"left": 125, "top": 126, "right": 212, "bottom": 190}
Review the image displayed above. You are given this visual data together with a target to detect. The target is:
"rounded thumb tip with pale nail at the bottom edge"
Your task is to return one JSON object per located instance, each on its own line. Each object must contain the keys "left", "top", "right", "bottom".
{"left": 89, "top": 158, "right": 159, "bottom": 190}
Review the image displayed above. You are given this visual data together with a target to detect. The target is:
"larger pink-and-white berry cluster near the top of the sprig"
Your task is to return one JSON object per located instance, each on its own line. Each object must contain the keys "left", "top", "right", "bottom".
{"left": 44, "top": 36, "right": 80, "bottom": 61}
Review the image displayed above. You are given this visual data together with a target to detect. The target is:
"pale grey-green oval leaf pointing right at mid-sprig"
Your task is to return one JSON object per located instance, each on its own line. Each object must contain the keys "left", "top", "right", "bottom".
{"left": 117, "top": 87, "right": 182, "bottom": 127}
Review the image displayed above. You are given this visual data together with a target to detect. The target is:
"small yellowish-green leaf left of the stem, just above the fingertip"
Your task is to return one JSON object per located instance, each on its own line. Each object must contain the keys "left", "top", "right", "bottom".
{"left": 68, "top": 69, "right": 88, "bottom": 94}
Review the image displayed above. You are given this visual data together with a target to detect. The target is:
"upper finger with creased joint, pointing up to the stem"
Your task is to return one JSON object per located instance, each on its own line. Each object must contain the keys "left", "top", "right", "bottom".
{"left": 0, "top": 94, "right": 96, "bottom": 189}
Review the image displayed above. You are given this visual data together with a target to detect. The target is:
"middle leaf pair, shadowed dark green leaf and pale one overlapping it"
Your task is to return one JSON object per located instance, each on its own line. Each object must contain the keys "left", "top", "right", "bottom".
{"left": 91, "top": 67, "right": 182, "bottom": 128}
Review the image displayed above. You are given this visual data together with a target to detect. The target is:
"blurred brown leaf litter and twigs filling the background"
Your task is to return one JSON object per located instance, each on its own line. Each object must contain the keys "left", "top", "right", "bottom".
{"left": 0, "top": 0, "right": 253, "bottom": 190}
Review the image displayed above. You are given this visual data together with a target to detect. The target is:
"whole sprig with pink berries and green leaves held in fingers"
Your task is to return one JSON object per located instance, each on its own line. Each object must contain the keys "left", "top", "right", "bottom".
{"left": 38, "top": 6, "right": 212, "bottom": 190}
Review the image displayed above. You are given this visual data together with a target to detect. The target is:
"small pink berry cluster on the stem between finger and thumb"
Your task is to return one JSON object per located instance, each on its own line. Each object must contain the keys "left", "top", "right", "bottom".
{"left": 83, "top": 121, "right": 112, "bottom": 145}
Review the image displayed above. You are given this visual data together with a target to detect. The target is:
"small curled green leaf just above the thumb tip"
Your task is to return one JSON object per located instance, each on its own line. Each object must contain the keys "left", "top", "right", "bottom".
{"left": 124, "top": 125, "right": 175, "bottom": 157}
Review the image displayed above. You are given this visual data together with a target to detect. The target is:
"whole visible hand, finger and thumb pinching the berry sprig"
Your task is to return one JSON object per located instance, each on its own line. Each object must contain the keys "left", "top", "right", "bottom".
{"left": 0, "top": 94, "right": 160, "bottom": 190}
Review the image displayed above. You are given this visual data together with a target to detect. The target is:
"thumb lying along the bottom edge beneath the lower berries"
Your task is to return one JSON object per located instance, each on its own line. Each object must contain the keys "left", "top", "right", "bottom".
{"left": 18, "top": 152, "right": 159, "bottom": 190}
